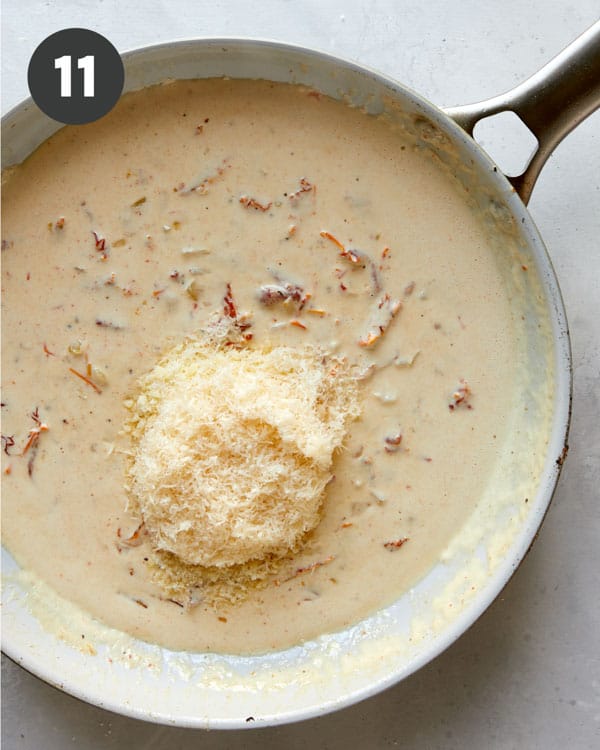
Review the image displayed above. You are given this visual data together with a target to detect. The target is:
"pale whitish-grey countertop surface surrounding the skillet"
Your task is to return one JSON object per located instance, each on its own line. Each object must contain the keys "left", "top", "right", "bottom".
{"left": 2, "top": 0, "right": 600, "bottom": 750}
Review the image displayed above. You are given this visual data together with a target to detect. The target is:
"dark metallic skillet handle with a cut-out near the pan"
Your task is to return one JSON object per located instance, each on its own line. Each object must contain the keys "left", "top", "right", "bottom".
{"left": 445, "top": 21, "right": 600, "bottom": 204}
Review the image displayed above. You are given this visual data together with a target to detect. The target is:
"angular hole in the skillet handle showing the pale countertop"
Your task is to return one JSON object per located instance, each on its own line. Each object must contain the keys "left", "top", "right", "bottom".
{"left": 473, "top": 111, "right": 539, "bottom": 177}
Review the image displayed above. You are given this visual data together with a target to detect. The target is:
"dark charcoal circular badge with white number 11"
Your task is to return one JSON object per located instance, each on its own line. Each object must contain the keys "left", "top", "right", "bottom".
{"left": 27, "top": 29, "right": 125, "bottom": 125}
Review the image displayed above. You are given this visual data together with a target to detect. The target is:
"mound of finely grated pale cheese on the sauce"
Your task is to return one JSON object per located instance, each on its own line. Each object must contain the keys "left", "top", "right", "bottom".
{"left": 120, "top": 318, "right": 359, "bottom": 592}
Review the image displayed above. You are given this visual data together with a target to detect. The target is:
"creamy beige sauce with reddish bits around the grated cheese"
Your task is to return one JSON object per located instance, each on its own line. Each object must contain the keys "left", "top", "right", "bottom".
{"left": 2, "top": 81, "right": 521, "bottom": 653}
